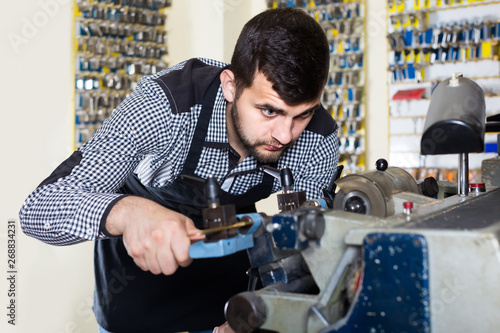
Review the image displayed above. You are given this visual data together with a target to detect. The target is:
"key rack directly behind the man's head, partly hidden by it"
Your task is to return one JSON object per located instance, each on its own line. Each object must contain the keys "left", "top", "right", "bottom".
{"left": 268, "top": 0, "right": 365, "bottom": 174}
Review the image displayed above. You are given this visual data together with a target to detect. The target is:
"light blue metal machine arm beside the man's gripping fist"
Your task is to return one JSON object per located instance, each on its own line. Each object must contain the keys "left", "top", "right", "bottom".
{"left": 189, "top": 213, "right": 262, "bottom": 259}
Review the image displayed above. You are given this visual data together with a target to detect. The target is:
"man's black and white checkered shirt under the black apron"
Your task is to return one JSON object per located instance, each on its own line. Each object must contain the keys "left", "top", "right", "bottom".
{"left": 19, "top": 59, "right": 338, "bottom": 245}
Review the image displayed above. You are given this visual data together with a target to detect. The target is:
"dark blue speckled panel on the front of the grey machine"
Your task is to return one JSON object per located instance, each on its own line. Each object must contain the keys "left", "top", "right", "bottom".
{"left": 330, "top": 233, "right": 430, "bottom": 333}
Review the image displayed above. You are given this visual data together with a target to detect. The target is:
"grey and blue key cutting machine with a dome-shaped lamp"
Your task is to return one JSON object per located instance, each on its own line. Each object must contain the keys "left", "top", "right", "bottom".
{"left": 190, "top": 75, "right": 500, "bottom": 333}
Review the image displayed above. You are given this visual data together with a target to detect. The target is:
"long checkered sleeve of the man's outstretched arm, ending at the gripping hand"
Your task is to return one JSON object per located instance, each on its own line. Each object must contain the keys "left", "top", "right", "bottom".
{"left": 19, "top": 78, "right": 172, "bottom": 245}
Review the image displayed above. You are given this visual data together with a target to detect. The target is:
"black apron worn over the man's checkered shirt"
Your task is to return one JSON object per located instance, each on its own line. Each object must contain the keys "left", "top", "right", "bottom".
{"left": 94, "top": 71, "right": 274, "bottom": 333}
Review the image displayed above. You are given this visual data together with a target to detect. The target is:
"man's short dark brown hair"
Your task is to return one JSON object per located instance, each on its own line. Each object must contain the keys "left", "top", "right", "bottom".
{"left": 230, "top": 8, "right": 330, "bottom": 105}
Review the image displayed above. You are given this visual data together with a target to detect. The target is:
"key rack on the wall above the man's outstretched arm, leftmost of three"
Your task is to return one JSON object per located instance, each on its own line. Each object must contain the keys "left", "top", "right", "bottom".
{"left": 74, "top": 0, "right": 171, "bottom": 148}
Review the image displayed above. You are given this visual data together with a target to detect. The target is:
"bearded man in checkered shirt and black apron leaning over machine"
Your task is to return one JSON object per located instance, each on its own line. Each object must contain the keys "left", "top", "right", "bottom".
{"left": 20, "top": 8, "right": 338, "bottom": 332}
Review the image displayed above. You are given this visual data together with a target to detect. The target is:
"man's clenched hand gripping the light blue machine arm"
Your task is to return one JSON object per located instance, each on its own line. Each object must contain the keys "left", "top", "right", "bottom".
{"left": 106, "top": 196, "right": 199, "bottom": 275}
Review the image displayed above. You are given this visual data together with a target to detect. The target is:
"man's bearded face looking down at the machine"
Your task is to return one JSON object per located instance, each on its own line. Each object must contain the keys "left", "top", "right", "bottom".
{"left": 224, "top": 73, "right": 319, "bottom": 163}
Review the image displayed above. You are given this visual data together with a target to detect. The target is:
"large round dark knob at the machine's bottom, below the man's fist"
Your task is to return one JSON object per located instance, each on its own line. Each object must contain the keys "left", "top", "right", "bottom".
{"left": 224, "top": 292, "right": 267, "bottom": 333}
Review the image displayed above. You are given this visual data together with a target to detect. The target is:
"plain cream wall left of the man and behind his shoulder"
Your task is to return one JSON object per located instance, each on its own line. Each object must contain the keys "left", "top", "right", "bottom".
{"left": 0, "top": 0, "right": 265, "bottom": 333}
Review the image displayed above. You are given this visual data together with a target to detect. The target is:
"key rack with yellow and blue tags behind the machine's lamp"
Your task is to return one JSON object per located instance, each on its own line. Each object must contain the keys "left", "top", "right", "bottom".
{"left": 387, "top": 0, "right": 500, "bottom": 181}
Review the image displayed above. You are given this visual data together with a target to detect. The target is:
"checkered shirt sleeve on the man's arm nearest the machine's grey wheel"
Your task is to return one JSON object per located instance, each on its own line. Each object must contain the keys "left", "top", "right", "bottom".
{"left": 293, "top": 131, "right": 339, "bottom": 200}
